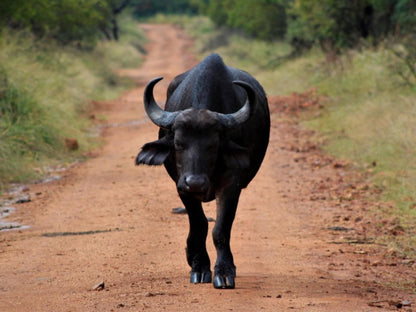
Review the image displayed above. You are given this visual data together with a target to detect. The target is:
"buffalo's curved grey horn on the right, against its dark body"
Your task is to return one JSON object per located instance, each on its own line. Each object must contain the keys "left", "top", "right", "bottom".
{"left": 217, "top": 80, "right": 256, "bottom": 128}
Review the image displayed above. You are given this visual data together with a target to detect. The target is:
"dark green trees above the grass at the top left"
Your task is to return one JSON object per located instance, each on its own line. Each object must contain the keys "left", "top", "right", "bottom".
{"left": 0, "top": 0, "right": 128, "bottom": 44}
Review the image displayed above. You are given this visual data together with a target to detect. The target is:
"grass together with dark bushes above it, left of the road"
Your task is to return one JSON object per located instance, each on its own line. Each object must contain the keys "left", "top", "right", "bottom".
{"left": 0, "top": 1, "right": 144, "bottom": 192}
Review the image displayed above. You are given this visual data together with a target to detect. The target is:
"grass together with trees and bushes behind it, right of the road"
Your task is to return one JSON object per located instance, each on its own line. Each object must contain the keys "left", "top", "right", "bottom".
{"left": 137, "top": 0, "right": 416, "bottom": 257}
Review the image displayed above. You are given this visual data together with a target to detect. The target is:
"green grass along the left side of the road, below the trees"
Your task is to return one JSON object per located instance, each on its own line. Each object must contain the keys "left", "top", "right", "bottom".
{"left": 0, "top": 17, "right": 144, "bottom": 191}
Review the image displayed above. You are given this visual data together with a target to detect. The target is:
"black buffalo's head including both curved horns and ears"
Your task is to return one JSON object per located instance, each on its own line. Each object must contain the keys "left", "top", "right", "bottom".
{"left": 136, "top": 77, "right": 256, "bottom": 198}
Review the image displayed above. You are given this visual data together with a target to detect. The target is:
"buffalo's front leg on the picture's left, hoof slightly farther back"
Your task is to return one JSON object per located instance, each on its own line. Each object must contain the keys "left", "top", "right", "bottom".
{"left": 181, "top": 196, "right": 212, "bottom": 283}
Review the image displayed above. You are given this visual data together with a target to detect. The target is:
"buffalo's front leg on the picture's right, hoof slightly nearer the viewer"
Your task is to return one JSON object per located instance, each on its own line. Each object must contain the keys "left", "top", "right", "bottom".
{"left": 212, "top": 188, "right": 241, "bottom": 288}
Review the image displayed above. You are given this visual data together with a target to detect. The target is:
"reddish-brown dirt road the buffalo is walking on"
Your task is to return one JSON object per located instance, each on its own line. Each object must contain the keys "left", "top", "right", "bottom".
{"left": 0, "top": 25, "right": 416, "bottom": 312}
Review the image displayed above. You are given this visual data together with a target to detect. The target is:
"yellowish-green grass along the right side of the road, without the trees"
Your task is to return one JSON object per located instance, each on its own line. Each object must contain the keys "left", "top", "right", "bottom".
{"left": 167, "top": 17, "right": 416, "bottom": 256}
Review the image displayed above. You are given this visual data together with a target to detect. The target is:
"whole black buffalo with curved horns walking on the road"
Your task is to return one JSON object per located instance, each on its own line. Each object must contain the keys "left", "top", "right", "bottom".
{"left": 136, "top": 54, "right": 270, "bottom": 288}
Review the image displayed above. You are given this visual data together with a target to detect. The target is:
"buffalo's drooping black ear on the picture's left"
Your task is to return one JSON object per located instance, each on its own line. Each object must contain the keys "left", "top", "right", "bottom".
{"left": 136, "top": 137, "right": 173, "bottom": 166}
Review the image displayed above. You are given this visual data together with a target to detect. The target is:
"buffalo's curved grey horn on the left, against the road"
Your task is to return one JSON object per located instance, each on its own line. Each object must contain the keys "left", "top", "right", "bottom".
{"left": 143, "top": 77, "right": 179, "bottom": 129}
